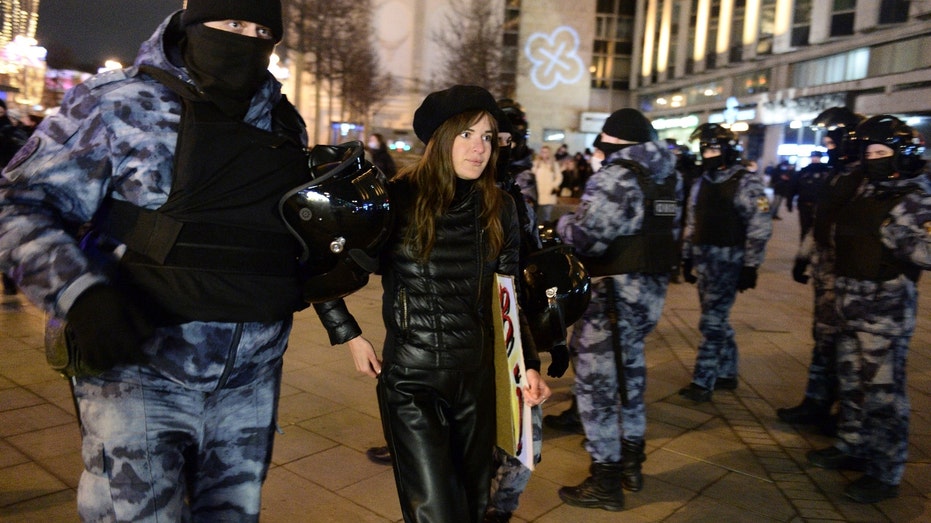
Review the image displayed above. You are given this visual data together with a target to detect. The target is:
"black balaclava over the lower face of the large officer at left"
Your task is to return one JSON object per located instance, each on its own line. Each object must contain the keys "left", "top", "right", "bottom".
{"left": 182, "top": 24, "right": 275, "bottom": 119}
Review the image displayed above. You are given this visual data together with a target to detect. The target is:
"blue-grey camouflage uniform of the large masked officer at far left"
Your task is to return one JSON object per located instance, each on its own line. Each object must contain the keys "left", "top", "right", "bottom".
{"left": 0, "top": 12, "right": 359, "bottom": 521}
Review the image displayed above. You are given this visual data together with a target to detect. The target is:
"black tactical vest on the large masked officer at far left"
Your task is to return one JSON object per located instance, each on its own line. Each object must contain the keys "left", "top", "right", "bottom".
{"left": 104, "top": 69, "right": 309, "bottom": 323}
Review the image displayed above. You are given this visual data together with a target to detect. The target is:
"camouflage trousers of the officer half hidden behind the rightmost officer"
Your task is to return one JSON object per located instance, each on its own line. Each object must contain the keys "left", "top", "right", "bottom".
{"left": 805, "top": 249, "right": 840, "bottom": 404}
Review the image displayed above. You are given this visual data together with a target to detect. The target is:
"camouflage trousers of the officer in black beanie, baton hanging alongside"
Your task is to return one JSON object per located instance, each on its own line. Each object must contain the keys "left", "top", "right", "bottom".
{"left": 570, "top": 274, "right": 669, "bottom": 463}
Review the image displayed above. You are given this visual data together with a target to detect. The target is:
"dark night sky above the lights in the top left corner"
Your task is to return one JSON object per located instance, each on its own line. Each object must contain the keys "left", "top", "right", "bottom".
{"left": 36, "top": 0, "right": 183, "bottom": 72}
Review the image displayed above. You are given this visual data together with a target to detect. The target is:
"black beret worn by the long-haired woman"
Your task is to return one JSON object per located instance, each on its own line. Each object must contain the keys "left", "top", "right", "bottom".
{"left": 414, "top": 85, "right": 513, "bottom": 143}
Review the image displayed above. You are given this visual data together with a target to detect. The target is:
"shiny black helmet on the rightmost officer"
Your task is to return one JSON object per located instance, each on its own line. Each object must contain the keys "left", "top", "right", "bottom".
{"left": 856, "top": 114, "right": 925, "bottom": 178}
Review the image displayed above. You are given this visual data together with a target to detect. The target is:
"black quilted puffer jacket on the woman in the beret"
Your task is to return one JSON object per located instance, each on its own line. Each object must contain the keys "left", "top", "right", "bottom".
{"left": 381, "top": 180, "right": 539, "bottom": 370}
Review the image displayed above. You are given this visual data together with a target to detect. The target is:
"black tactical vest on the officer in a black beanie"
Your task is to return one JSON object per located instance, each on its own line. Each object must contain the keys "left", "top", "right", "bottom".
{"left": 580, "top": 159, "right": 681, "bottom": 276}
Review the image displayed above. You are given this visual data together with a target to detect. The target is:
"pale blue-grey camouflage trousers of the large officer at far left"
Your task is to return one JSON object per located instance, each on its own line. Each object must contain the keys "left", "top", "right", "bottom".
{"left": 74, "top": 358, "right": 281, "bottom": 522}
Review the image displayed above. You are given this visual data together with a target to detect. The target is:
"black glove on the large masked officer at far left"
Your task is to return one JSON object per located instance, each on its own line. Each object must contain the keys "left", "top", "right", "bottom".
{"left": 66, "top": 285, "right": 154, "bottom": 376}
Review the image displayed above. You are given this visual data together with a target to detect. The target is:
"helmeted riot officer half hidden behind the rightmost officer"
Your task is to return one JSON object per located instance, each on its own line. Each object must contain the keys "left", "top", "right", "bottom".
{"left": 776, "top": 107, "right": 864, "bottom": 434}
